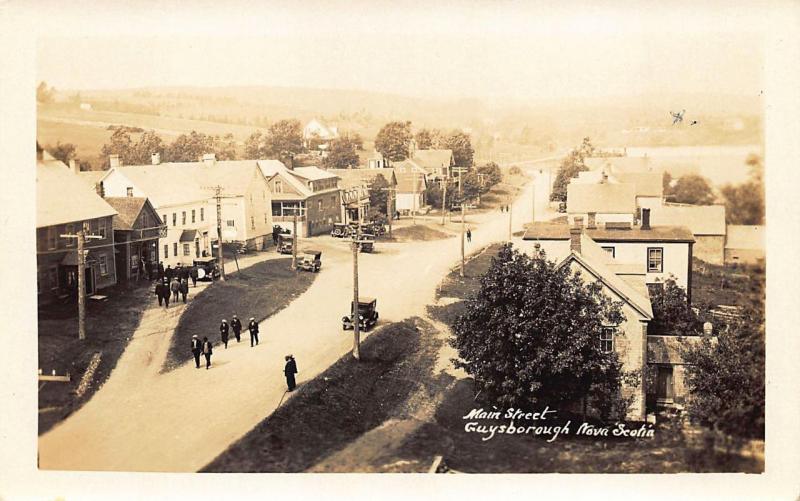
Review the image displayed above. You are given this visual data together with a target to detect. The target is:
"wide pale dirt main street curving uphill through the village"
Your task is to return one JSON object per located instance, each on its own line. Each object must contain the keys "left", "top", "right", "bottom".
{"left": 39, "top": 169, "right": 552, "bottom": 472}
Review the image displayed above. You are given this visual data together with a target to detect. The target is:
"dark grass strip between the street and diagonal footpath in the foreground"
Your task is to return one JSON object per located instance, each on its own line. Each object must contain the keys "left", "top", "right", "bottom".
{"left": 201, "top": 318, "right": 440, "bottom": 473}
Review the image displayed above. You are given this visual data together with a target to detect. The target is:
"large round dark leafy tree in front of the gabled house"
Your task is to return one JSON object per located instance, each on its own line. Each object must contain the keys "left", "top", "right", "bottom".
{"left": 451, "top": 244, "right": 624, "bottom": 412}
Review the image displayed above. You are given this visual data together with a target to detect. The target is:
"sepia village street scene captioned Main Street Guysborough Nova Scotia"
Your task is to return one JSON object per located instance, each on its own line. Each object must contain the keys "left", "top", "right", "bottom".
{"left": 0, "top": 2, "right": 797, "bottom": 495}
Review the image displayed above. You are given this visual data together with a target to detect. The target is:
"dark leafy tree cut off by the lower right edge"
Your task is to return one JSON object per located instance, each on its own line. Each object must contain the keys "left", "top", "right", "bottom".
{"left": 682, "top": 301, "right": 766, "bottom": 438}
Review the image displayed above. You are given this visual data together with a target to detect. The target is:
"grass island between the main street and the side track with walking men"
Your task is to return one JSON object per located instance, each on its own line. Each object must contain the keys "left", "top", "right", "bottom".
{"left": 162, "top": 258, "right": 317, "bottom": 372}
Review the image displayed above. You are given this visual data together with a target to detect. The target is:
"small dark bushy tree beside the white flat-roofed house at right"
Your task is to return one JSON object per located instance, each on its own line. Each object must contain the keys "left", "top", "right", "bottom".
{"left": 648, "top": 277, "right": 702, "bottom": 336}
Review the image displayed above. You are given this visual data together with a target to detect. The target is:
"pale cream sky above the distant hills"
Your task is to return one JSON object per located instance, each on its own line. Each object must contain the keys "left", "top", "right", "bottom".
{"left": 36, "top": 0, "right": 766, "bottom": 100}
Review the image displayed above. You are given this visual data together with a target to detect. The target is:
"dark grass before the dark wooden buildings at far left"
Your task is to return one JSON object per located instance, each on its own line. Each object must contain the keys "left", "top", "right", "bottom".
{"left": 38, "top": 281, "right": 152, "bottom": 434}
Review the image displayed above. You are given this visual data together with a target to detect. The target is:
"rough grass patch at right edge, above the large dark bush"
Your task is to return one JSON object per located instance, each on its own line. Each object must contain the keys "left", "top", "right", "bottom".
{"left": 692, "top": 258, "right": 766, "bottom": 306}
